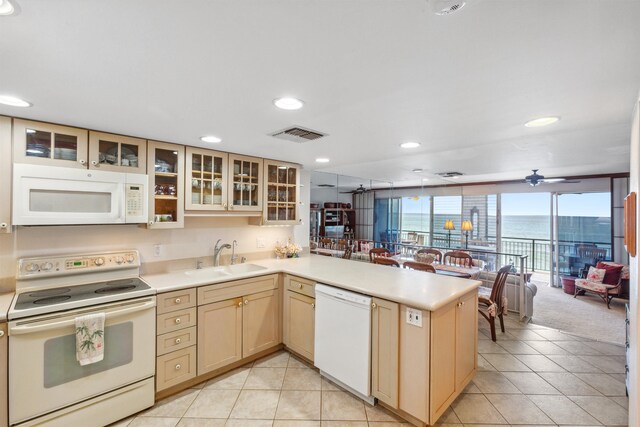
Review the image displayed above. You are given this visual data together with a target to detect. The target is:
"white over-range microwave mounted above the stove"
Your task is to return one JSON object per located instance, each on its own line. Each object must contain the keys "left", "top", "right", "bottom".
{"left": 12, "top": 163, "right": 149, "bottom": 225}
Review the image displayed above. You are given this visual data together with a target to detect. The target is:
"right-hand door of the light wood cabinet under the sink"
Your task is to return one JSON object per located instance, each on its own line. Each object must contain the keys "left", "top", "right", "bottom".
{"left": 242, "top": 289, "right": 282, "bottom": 357}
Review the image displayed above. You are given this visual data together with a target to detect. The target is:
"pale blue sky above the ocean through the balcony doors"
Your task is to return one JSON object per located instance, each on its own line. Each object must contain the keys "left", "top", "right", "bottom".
{"left": 402, "top": 193, "right": 611, "bottom": 218}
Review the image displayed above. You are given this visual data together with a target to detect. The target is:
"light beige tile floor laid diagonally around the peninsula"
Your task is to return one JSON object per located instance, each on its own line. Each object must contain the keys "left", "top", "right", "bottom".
{"left": 113, "top": 317, "right": 628, "bottom": 427}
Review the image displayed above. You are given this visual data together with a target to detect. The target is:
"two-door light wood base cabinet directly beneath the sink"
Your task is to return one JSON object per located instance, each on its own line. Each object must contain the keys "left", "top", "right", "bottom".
{"left": 198, "top": 275, "right": 282, "bottom": 375}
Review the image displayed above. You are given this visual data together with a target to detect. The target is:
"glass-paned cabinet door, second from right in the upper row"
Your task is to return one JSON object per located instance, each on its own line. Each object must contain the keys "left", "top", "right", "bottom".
{"left": 227, "top": 154, "right": 262, "bottom": 211}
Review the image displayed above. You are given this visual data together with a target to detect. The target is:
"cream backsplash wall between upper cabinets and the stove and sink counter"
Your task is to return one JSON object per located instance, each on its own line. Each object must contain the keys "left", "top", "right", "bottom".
{"left": 0, "top": 217, "right": 309, "bottom": 291}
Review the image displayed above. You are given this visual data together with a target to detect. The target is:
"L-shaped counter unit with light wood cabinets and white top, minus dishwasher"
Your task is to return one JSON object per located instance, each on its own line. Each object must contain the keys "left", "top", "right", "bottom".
{"left": 143, "top": 255, "right": 480, "bottom": 425}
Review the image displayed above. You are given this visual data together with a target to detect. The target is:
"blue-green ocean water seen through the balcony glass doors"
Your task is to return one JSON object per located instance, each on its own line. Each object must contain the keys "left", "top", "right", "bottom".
{"left": 402, "top": 213, "right": 611, "bottom": 243}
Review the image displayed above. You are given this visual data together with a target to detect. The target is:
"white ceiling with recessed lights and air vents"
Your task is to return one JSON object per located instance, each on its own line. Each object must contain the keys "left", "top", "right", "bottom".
{"left": 0, "top": 0, "right": 640, "bottom": 186}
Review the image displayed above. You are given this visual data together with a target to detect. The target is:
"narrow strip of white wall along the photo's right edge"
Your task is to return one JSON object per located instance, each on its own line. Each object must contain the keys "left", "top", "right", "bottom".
{"left": 629, "top": 99, "right": 640, "bottom": 426}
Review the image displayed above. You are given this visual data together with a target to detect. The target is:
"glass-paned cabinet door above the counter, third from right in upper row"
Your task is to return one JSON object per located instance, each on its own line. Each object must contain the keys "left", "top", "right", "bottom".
{"left": 185, "top": 147, "right": 229, "bottom": 211}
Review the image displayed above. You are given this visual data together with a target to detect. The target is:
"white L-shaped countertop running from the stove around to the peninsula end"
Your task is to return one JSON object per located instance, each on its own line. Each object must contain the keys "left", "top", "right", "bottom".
{"left": 142, "top": 255, "right": 481, "bottom": 311}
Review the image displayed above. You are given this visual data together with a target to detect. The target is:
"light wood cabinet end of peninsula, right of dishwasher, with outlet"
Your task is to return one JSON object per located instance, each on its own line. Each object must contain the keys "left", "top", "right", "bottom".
{"left": 399, "top": 289, "right": 478, "bottom": 424}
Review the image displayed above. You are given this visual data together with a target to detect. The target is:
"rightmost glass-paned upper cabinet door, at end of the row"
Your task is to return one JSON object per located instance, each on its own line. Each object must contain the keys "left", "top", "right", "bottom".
{"left": 263, "top": 160, "right": 300, "bottom": 224}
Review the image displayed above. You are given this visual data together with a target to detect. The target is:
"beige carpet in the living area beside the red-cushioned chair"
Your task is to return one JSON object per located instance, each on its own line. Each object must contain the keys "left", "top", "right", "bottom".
{"left": 531, "top": 273, "right": 628, "bottom": 344}
